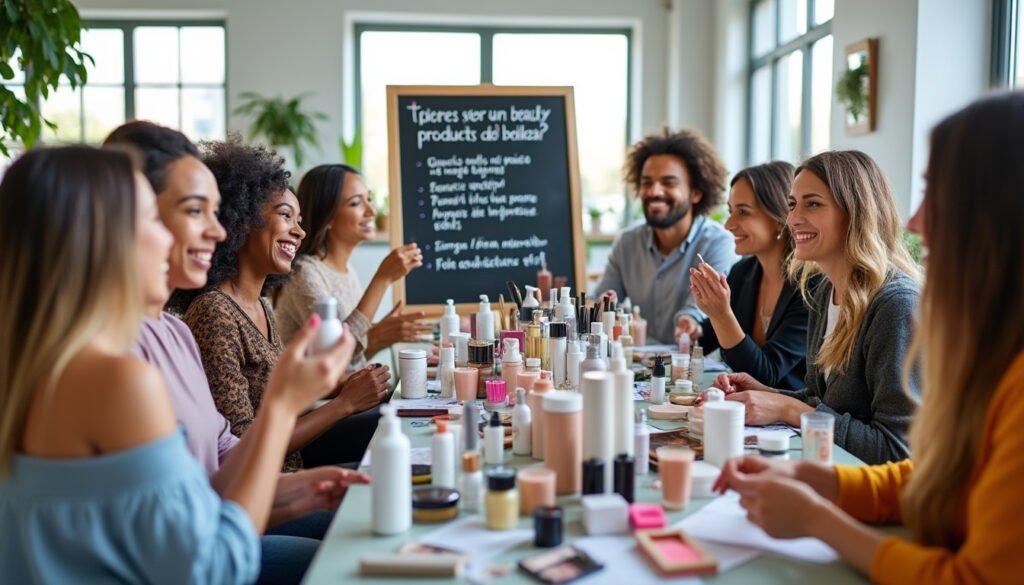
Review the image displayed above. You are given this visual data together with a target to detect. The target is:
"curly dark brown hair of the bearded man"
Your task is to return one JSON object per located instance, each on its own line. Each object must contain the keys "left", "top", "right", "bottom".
{"left": 623, "top": 127, "right": 726, "bottom": 215}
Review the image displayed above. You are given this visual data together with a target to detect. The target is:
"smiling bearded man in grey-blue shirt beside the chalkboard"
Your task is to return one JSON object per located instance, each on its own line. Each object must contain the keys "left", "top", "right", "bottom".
{"left": 595, "top": 128, "right": 739, "bottom": 343}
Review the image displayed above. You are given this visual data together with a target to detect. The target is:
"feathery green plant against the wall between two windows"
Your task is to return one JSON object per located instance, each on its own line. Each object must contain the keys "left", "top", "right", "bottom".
{"left": 234, "top": 91, "right": 327, "bottom": 167}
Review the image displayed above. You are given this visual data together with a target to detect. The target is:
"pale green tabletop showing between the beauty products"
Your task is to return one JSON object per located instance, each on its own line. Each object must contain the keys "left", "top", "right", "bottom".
{"left": 303, "top": 376, "right": 867, "bottom": 585}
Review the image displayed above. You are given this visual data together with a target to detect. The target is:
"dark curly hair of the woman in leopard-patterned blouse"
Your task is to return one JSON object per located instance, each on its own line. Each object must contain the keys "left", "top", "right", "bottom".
{"left": 168, "top": 133, "right": 292, "bottom": 314}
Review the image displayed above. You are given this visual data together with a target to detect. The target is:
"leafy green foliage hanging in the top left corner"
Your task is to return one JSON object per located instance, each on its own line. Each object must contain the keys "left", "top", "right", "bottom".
{"left": 0, "top": 0, "right": 92, "bottom": 156}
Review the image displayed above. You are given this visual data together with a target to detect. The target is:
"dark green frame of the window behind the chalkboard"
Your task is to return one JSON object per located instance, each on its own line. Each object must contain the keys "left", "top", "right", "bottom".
{"left": 352, "top": 22, "right": 636, "bottom": 226}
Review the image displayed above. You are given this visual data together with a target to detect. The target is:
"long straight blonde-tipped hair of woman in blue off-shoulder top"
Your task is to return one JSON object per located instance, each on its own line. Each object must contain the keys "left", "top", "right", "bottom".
{"left": 0, "top": 147, "right": 142, "bottom": 475}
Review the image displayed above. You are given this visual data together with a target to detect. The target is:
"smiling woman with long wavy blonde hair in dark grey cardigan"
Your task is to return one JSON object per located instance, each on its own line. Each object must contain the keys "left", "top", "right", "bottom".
{"left": 716, "top": 151, "right": 920, "bottom": 463}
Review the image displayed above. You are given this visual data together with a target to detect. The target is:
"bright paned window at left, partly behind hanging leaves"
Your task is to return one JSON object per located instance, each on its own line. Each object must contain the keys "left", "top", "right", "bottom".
{"left": 13, "top": 22, "right": 226, "bottom": 143}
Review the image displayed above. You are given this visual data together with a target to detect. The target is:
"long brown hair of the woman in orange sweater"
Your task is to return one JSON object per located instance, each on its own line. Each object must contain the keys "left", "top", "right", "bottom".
{"left": 902, "top": 92, "right": 1024, "bottom": 549}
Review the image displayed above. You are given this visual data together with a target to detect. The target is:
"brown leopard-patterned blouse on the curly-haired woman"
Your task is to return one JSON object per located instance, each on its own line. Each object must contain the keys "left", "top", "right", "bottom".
{"left": 184, "top": 289, "right": 302, "bottom": 471}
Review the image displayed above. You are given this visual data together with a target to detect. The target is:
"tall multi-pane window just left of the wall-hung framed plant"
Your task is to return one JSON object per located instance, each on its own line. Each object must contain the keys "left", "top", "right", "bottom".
{"left": 746, "top": 0, "right": 835, "bottom": 164}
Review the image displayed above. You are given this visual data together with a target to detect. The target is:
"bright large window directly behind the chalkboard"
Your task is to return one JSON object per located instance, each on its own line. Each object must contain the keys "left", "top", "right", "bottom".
{"left": 355, "top": 25, "right": 631, "bottom": 229}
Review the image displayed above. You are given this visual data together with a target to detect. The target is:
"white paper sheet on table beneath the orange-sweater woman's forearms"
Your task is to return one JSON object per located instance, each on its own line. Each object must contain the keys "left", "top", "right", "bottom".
{"left": 676, "top": 492, "right": 839, "bottom": 562}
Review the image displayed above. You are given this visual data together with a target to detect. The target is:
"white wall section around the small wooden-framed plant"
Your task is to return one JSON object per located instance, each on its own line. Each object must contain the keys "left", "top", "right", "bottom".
{"left": 831, "top": 0, "right": 991, "bottom": 217}
